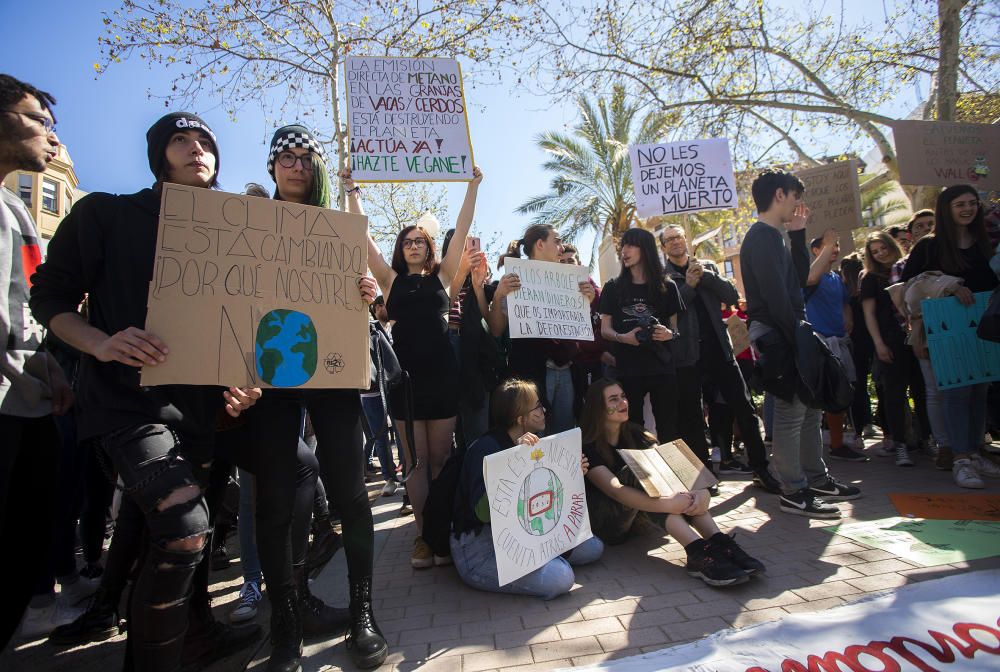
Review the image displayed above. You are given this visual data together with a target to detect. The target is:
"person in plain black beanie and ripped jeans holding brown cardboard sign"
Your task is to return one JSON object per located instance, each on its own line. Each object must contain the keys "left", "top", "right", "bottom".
{"left": 31, "top": 107, "right": 260, "bottom": 672}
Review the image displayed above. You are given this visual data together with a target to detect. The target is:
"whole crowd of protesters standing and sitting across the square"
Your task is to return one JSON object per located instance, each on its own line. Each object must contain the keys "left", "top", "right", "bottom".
{"left": 0, "top": 75, "right": 1000, "bottom": 672}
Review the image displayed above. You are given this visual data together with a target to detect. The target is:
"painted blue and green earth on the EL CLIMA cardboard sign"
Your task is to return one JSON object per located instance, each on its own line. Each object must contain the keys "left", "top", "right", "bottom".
{"left": 255, "top": 310, "right": 318, "bottom": 387}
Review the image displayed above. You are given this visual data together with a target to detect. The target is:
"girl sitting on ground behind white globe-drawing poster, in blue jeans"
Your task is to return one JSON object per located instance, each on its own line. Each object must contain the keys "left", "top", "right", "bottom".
{"left": 451, "top": 379, "right": 604, "bottom": 600}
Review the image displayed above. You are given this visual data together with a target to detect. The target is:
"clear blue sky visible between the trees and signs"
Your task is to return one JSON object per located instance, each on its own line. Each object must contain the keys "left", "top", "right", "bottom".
{"left": 0, "top": 0, "right": 916, "bottom": 270}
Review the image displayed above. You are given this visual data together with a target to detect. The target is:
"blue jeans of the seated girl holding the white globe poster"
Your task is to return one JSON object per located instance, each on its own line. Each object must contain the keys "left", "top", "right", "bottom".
{"left": 451, "top": 525, "right": 604, "bottom": 600}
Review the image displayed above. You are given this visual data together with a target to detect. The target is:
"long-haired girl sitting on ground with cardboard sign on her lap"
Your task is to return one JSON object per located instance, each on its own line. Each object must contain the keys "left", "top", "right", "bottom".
{"left": 581, "top": 378, "right": 764, "bottom": 586}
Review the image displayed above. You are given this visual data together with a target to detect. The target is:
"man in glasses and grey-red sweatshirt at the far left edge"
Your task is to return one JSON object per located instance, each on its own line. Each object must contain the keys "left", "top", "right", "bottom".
{"left": 0, "top": 75, "right": 73, "bottom": 650}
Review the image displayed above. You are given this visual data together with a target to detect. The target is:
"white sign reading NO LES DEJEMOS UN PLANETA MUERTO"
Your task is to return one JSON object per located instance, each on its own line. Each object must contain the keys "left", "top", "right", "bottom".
{"left": 628, "top": 138, "right": 738, "bottom": 217}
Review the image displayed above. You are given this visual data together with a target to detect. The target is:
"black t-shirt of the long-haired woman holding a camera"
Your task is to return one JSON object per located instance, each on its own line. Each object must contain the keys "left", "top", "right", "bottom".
{"left": 601, "top": 278, "right": 684, "bottom": 376}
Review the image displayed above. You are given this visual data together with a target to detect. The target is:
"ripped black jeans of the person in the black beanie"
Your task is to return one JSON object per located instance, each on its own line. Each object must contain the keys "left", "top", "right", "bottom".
{"left": 102, "top": 424, "right": 213, "bottom": 672}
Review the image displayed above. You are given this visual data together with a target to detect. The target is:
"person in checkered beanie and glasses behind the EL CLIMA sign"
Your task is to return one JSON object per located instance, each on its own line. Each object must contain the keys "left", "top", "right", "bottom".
{"left": 240, "top": 124, "right": 388, "bottom": 672}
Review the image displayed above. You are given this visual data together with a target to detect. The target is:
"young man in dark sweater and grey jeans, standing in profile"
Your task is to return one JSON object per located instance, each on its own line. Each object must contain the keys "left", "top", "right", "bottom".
{"left": 740, "top": 170, "right": 861, "bottom": 518}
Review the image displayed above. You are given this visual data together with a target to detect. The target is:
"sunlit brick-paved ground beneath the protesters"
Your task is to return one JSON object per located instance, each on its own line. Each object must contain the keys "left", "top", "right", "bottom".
{"left": 0, "top": 441, "right": 1000, "bottom": 672}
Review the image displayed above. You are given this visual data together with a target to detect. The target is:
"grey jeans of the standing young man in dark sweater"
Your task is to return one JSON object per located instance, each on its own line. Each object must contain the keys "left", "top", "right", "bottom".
{"left": 771, "top": 395, "right": 827, "bottom": 495}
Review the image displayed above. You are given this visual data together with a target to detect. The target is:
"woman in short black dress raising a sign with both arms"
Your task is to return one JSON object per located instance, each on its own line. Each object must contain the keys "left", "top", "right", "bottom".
{"left": 341, "top": 166, "right": 483, "bottom": 568}
